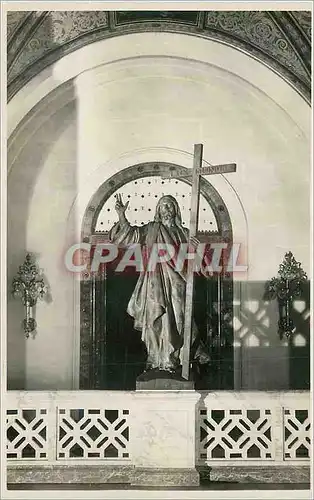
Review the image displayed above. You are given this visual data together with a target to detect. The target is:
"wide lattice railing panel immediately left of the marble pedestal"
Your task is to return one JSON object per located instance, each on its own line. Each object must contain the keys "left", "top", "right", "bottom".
{"left": 57, "top": 408, "right": 130, "bottom": 460}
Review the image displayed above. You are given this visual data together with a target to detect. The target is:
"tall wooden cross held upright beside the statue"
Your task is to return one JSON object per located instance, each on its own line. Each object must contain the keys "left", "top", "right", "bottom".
{"left": 165, "top": 144, "right": 237, "bottom": 380}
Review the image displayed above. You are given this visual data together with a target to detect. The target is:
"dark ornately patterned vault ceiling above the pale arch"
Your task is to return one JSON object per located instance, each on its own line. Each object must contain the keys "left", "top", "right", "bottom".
{"left": 7, "top": 11, "right": 311, "bottom": 101}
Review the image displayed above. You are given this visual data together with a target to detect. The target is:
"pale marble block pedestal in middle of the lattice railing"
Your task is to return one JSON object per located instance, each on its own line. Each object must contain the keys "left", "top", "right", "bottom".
{"left": 131, "top": 390, "right": 200, "bottom": 487}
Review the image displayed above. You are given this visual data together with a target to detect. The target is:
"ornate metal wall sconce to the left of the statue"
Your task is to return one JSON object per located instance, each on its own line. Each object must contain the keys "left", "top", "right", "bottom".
{"left": 12, "top": 254, "right": 47, "bottom": 338}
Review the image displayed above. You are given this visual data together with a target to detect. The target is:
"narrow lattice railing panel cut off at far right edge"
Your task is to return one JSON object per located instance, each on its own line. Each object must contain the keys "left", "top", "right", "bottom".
{"left": 284, "top": 408, "right": 311, "bottom": 460}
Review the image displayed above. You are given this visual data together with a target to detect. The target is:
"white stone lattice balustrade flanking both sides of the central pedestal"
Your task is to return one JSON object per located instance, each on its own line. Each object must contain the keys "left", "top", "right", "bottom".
{"left": 6, "top": 391, "right": 311, "bottom": 466}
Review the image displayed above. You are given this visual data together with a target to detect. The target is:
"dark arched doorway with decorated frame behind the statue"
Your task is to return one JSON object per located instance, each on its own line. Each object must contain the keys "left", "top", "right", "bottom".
{"left": 80, "top": 162, "right": 234, "bottom": 390}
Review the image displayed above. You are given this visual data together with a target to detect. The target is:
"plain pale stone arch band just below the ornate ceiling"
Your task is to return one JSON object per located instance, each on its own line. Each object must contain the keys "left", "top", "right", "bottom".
{"left": 7, "top": 32, "right": 310, "bottom": 139}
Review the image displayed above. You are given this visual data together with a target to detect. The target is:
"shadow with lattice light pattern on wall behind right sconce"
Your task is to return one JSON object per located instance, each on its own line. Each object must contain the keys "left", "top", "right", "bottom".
{"left": 234, "top": 282, "right": 310, "bottom": 390}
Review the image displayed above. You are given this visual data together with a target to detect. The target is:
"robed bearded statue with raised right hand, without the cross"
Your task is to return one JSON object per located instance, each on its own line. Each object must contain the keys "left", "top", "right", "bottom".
{"left": 109, "top": 195, "right": 209, "bottom": 372}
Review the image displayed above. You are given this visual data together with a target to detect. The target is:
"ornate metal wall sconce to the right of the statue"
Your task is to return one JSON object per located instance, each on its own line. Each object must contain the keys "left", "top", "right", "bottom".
{"left": 266, "top": 252, "right": 307, "bottom": 339}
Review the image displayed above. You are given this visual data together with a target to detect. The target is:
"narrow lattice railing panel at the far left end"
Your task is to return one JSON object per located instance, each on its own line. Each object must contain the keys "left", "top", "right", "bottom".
{"left": 7, "top": 408, "right": 48, "bottom": 460}
